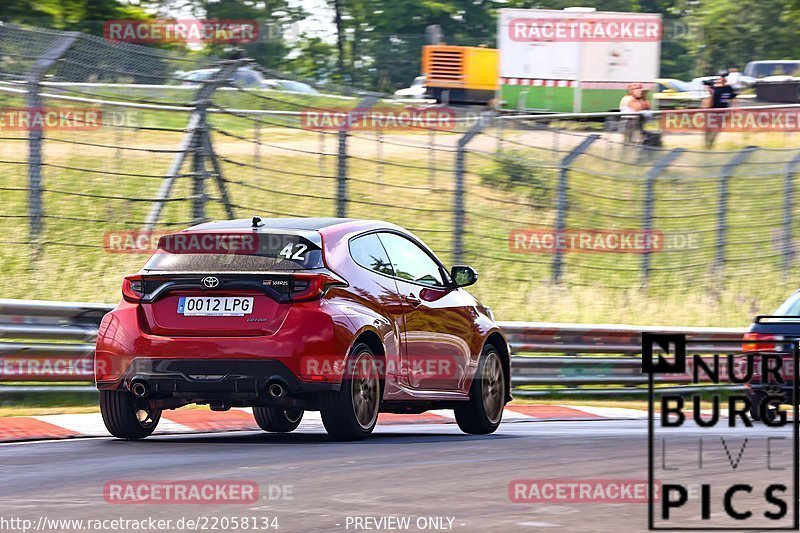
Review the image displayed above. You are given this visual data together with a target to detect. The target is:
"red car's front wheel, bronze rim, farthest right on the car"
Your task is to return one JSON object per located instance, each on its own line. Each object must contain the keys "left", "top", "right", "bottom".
{"left": 455, "top": 344, "right": 506, "bottom": 435}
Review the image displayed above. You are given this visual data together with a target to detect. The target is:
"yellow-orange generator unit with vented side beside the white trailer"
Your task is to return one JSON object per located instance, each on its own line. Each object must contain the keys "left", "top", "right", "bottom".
{"left": 422, "top": 44, "right": 500, "bottom": 104}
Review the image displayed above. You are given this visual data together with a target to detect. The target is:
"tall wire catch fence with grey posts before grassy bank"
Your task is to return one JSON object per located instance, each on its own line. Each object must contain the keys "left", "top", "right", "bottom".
{"left": 0, "top": 26, "right": 800, "bottom": 325}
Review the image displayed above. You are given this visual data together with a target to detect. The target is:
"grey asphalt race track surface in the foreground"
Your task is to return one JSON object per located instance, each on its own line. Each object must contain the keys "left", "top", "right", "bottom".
{"left": 0, "top": 420, "right": 792, "bottom": 532}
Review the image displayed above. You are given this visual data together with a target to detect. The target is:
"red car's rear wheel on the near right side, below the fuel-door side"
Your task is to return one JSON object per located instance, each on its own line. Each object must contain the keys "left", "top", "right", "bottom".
{"left": 320, "top": 343, "right": 381, "bottom": 441}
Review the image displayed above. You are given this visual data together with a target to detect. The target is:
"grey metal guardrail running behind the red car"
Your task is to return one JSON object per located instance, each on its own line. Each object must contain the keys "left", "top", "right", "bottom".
{"left": 0, "top": 299, "right": 744, "bottom": 396}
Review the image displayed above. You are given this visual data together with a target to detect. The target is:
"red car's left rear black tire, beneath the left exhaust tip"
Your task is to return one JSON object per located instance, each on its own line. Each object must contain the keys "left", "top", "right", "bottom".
{"left": 100, "top": 390, "right": 161, "bottom": 440}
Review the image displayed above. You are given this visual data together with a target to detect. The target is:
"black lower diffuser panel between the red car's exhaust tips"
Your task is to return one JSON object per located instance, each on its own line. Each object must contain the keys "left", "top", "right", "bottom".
{"left": 97, "top": 358, "right": 340, "bottom": 401}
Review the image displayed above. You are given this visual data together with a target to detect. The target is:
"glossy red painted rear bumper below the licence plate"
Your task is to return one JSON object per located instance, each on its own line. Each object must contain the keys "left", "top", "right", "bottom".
{"left": 95, "top": 302, "right": 354, "bottom": 386}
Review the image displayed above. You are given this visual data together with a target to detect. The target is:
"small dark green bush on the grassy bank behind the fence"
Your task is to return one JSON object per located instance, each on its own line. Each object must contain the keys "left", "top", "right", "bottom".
{"left": 480, "top": 151, "right": 552, "bottom": 207}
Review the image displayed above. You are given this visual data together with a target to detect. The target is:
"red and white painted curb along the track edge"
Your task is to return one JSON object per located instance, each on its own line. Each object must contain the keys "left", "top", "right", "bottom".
{"left": 0, "top": 405, "right": 647, "bottom": 442}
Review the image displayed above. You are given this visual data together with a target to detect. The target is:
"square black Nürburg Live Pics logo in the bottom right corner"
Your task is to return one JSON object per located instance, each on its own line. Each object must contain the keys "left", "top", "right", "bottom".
{"left": 642, "top": 333, "right": 800, "bottom": 531}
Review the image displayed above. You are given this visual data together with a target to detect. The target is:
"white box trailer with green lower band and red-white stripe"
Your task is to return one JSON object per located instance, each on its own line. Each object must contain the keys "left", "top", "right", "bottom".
{"left": 497, "top": 8, "right": 662, "bottom": 113}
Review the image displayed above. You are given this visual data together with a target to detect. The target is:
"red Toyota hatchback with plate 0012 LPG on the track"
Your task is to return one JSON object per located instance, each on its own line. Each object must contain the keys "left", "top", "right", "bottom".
{"left": 95, "top": 217, "right": 511, "bottom": 440}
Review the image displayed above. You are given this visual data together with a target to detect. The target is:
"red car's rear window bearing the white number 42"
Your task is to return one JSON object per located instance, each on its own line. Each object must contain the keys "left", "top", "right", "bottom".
{"left": 144, "top": 232, "right": 324, "bottom": 272}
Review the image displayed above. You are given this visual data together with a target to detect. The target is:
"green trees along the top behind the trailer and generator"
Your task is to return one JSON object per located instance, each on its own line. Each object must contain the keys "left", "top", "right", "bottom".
{"left": 0, "top": 0, "right": 800, "bottom": 91}
